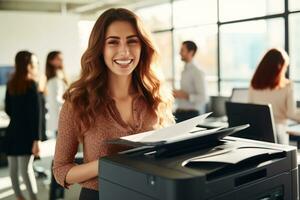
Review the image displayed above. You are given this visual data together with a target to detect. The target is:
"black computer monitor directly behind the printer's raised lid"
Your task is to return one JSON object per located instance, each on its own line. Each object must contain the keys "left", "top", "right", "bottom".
{"left": 226, "top": 102, "right": 277, "bottom": 143}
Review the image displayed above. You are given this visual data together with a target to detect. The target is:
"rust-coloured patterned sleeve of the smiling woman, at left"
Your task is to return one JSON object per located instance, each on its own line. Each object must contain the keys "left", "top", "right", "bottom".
{"left": 53, "top": 103, "right": 79, "bottom": 188}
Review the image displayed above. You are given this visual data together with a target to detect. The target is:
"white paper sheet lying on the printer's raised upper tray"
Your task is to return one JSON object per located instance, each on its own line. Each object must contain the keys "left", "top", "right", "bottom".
{"left": 121, "top": 113, "right": 212, "bottom": 143}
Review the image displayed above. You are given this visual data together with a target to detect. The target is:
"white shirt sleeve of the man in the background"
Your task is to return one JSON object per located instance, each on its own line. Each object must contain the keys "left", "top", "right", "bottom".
{"left": 189, "top": 70, "right": 207, "bottom": 105}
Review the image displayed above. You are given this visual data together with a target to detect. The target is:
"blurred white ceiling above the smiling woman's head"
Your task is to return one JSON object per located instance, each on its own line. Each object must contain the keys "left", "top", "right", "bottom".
{"left": 0, "top": 0, "right": 170, "bottom": 18}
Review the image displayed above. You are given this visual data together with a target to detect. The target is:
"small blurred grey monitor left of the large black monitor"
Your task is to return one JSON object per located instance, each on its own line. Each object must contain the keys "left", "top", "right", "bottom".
{"left": 208, "top": 96, "right": 230, "bottom": 117}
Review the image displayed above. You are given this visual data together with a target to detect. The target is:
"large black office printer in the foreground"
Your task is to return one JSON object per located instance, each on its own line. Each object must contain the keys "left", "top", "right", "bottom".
{"left": 99, "top": 126, "right": 298, "bottom": 200}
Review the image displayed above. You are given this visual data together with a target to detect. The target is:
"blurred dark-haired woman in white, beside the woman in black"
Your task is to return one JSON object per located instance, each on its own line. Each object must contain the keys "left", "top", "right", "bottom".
{"left": 46, "top": 51, "right": 68, "bottom": 136}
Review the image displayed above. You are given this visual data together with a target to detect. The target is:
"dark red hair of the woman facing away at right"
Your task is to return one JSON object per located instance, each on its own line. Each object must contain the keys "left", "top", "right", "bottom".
{"left": 251, "top": 48, "right": 289, "bottom": 89}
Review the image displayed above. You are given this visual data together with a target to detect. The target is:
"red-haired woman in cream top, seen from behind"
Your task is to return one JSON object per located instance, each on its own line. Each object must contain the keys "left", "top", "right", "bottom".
{"left": 249, "top": 48, "right": 300, "bottom": 144}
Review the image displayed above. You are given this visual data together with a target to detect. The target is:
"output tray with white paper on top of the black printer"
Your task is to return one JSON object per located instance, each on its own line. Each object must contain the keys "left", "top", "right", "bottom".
{"left": 182, "top": 147, "right": 286, "bottom": 181}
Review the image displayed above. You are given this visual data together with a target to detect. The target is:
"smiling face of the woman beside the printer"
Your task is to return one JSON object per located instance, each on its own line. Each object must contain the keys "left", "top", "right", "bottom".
{"left": 103, "top": 21, "right": 141, "bottom": 76}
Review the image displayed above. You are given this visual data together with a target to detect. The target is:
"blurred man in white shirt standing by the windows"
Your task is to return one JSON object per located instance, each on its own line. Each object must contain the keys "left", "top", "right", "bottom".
{"left": 173, "top": 41, "right": 208, "bottom": 122}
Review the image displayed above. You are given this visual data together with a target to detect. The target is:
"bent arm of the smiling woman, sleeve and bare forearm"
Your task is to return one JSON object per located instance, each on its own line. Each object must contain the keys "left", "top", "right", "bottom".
{"left": 53, "top": 102, "right": 98, "bottom": 188}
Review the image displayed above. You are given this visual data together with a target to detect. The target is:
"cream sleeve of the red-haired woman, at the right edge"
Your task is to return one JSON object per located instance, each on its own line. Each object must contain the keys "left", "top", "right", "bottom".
{"left": 286, "top": 83, "right": 300, "bottom": 122}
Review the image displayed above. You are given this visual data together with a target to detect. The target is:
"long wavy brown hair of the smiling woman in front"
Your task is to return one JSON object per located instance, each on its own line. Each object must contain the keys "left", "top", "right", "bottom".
{"left": 64, "top": 8, "right": 174, "bottom": 130}
